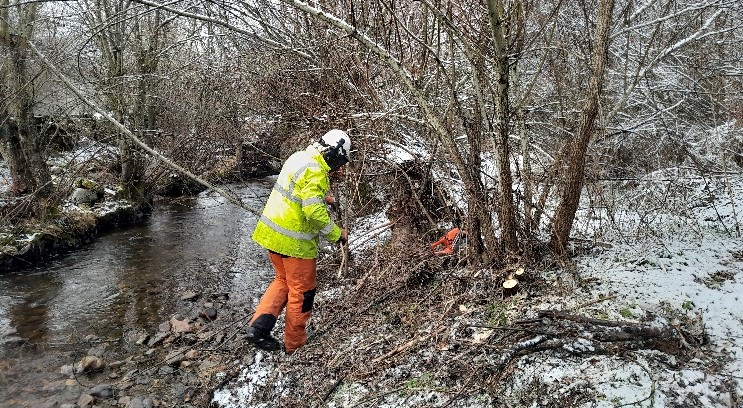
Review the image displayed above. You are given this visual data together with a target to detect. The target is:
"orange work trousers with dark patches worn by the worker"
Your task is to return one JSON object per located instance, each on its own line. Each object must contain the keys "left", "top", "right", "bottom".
{"left": 250, "top": 252, "right": 317, "bottom": 353}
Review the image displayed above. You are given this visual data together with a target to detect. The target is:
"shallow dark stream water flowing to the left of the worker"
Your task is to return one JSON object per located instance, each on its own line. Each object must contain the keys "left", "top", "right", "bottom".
{"left": 0, "top": 180, "right": 273, "bottom": 406}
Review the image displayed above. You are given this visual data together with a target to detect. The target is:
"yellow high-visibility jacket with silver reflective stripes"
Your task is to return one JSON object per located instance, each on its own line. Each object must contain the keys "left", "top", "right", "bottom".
{"left": 253, "top": 146, "right": 341, "bottom": 259}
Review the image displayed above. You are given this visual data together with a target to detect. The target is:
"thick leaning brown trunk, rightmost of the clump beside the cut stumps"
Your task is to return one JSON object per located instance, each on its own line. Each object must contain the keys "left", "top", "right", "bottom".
{"left": 551, "top": 0, "right": 614, "bottom": 256}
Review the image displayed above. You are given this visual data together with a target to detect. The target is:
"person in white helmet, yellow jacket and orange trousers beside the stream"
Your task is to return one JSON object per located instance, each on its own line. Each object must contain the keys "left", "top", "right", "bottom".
{"left": 246, "top": 129, "right": 351, "bottom": 353}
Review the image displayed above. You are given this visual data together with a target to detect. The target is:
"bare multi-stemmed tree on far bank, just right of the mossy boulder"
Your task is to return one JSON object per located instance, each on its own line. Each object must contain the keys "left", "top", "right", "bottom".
{"left": 80, "top": 0, "right": 176, "bottom": 201}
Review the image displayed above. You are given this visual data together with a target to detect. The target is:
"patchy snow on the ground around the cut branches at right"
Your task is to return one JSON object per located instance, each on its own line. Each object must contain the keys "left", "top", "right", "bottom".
{"left": 508, "top": 174, "right": 743, "bottom": 407}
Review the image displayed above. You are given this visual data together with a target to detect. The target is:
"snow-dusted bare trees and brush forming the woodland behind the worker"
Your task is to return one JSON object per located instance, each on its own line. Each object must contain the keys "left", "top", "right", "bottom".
{"left": 0, "top": 0, "right": 743, "bottom": 264}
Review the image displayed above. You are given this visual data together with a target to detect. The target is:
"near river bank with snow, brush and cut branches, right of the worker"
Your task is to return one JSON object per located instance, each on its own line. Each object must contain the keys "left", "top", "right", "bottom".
{"left": 212, "top": 174, "right": 743, "bottom": 408}
